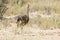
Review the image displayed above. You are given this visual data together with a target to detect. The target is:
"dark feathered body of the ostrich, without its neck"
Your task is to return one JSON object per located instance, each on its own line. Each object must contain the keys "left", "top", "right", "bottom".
{"left": 17, "top": 15, "right": 29, "bottom": 27}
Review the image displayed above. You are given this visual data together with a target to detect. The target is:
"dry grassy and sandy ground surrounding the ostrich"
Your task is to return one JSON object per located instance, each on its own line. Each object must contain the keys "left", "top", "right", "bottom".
{"left": 0, "top": 0, "right": 60, "bottom": 40}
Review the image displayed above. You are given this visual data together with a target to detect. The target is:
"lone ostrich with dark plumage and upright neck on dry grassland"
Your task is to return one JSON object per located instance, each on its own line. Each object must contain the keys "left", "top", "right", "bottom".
{"left": 16, "top": 4, "right": 29, "bottom": 31}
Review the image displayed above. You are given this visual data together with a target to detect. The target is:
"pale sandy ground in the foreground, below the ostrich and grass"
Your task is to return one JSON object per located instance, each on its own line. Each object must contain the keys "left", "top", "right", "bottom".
{"left": 0, "top": 25, "right": 60, "bottom": 40}
